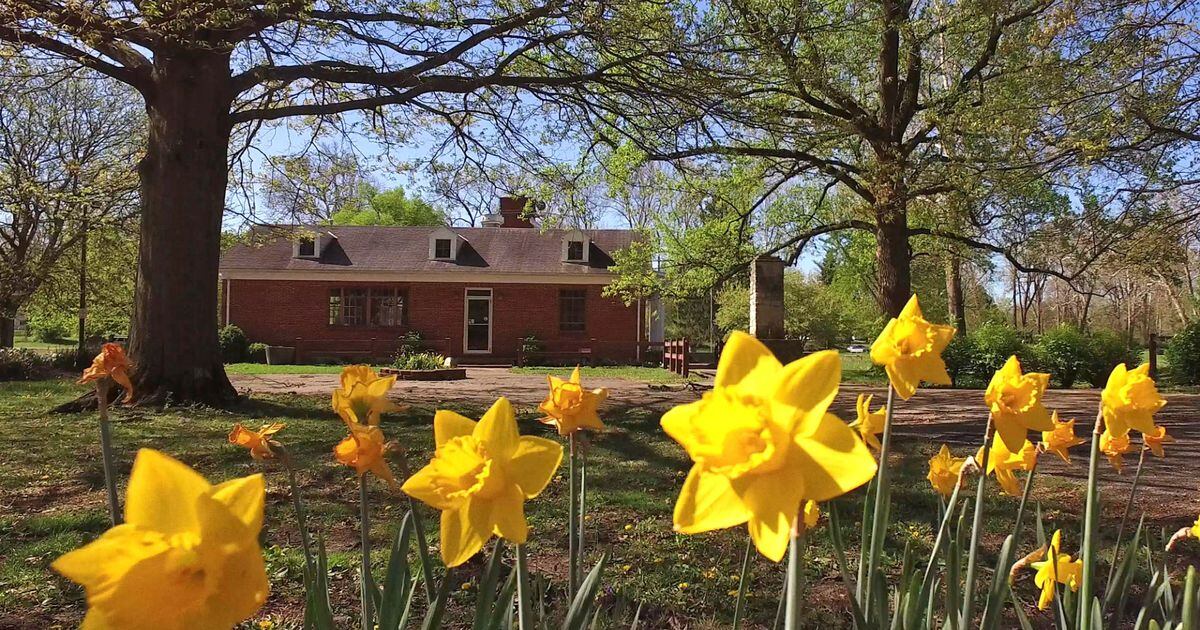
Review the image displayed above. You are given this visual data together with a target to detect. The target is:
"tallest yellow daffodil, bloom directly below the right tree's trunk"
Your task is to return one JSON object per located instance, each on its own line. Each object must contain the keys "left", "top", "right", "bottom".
{"left": 871, "top": 295, "right": 954, "bottom": 400}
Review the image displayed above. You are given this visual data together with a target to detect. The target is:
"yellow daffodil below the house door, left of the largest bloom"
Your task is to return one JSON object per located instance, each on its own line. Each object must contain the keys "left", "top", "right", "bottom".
{"left": 403, "top": 398, "right": 563, "bottom": 566}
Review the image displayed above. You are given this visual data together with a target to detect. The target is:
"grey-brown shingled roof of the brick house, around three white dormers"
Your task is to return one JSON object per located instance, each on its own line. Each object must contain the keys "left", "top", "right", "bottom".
{"left": 221, "top": 226, "right": 637, "bottom": 274}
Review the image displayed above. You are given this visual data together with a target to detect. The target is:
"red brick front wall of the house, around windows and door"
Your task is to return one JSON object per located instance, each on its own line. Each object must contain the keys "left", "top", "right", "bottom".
{"left": 222, "top": 280, "right": 638, "bottom": 361}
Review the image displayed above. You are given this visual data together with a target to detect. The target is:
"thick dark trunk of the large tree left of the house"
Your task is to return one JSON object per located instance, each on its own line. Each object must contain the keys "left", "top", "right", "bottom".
{"left": 130, "top": 52, "right": 236, "bottom": 404}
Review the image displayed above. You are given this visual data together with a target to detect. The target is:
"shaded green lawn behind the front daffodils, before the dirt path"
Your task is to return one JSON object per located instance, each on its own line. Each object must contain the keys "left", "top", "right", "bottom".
{"left": 0, "top": 380, "right": 1161, "bottom": 628}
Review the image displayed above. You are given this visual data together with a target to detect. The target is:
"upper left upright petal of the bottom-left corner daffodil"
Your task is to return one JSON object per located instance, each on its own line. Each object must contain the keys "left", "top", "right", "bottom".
{"left": 125, "top": 449, "right": 211, "bottom": 535}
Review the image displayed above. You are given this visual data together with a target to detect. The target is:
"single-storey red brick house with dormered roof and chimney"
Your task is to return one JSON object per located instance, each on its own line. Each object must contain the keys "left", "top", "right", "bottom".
{"left": 221, "top": 198, "right": 646, "bottom": 364}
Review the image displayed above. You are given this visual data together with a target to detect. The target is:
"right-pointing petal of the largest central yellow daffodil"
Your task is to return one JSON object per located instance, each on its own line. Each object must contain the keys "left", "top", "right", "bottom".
{"left": 792, "top": 413, "right": 877, "bottom": 503}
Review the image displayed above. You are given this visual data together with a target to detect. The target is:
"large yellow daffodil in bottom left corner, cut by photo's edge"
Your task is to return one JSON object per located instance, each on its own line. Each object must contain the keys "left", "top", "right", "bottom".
{"left": 52, "top": 449, "right": 268, "bottom": 630}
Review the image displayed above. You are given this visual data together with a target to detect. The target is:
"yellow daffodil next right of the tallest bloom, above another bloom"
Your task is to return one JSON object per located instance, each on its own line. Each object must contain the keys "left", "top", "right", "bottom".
{"left": 983, "top": 356, "right": 1054, "bottom": 451}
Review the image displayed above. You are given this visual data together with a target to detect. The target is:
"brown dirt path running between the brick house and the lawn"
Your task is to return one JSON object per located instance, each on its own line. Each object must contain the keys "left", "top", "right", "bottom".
{"left": 230, "top": 367, "right": 1200, "bottom": 520}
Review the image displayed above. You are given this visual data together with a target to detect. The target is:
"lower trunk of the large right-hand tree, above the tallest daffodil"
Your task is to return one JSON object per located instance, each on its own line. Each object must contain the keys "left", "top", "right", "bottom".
{"left": 875, "top": 180, "right": 912, "bottom": 317}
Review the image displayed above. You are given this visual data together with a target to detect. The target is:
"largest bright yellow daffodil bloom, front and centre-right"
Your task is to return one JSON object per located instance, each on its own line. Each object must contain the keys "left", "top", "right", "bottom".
{"left": 662, "top": 332, "right": 876, "bottom": 562}
